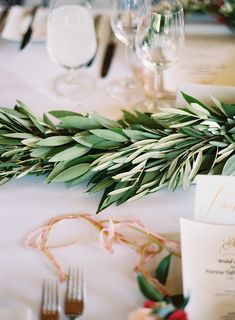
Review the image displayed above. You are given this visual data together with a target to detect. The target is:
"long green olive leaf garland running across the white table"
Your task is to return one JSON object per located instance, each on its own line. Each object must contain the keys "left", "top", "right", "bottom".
{"left": 0, "top": 93, "right": 235, "bottom": 212}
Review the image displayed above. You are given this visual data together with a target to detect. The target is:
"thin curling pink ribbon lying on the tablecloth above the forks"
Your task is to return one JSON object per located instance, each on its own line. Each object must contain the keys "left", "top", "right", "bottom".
{"left": 25, "top": 214, "right": 180, "bottom": 294}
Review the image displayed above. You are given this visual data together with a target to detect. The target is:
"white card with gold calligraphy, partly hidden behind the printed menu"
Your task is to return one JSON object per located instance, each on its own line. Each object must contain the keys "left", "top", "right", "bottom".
{"left": 194, "top": 175, "right": 235, "bottom": 225}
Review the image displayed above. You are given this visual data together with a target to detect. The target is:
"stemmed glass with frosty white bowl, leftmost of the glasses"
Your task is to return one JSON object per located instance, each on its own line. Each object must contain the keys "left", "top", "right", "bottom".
{"left": 47, "top": 0, "right": 97, "bottom": 100}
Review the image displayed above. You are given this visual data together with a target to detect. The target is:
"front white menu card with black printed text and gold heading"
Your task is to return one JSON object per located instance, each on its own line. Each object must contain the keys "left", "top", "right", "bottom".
{"left": 180, "top": 219, "right": 235, "bottom": 320}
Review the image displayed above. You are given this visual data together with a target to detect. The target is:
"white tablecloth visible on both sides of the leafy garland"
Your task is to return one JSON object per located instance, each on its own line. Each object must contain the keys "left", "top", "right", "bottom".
{"left": 0, "top": 9, "right": 234, "bottom": 320}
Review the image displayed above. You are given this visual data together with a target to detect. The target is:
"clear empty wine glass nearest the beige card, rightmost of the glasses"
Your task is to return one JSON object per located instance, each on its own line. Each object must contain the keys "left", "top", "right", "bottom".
{"left": 135, "top": 0, "right": 184, "bottom": 107}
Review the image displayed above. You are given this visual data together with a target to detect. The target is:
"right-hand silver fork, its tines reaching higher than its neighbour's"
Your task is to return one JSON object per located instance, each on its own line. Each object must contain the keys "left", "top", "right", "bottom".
{"left": 64, "top": 268, "right": 85, "bottom": 320}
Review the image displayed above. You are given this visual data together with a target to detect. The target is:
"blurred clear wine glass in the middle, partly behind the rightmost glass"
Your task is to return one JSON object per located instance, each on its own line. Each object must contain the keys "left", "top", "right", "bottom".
{"left": 107, "top": 0, "right": 145, "bottom": 101}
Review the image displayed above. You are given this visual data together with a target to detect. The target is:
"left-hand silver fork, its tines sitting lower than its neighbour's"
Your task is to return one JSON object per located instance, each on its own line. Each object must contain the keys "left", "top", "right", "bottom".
{"left": 40, "top": 279, "right": 60, "bottom": 320}
